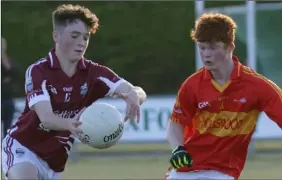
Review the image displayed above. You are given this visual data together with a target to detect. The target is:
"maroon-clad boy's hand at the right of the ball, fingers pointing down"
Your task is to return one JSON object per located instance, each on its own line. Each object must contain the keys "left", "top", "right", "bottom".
{"left": 120, "top": 90, "right": 140, "bottom": 123}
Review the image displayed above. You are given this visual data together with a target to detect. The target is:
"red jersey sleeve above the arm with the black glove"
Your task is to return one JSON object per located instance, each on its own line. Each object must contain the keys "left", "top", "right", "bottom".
{"left": 170, "top": 81, "right": 197, "bottom": 128}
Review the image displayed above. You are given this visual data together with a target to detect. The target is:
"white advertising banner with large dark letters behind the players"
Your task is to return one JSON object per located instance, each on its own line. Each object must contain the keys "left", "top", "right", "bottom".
{"left": 14, "top": 96, "right": 282, "bottom": 142}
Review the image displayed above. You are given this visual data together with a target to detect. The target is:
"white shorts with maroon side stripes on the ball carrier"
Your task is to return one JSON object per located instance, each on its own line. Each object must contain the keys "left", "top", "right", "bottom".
{"left": 2, "top": 135, "right": 61, "bottom": 180}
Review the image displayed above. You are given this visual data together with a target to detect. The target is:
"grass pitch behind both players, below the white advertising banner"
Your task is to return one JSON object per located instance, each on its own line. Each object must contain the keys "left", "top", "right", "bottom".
{"left": 62, "top": 140, "right": 282, "bottom": 180}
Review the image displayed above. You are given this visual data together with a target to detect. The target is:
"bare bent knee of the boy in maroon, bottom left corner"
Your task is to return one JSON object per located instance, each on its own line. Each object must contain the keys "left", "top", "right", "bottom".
{"left": 7, "top": 162, "right": 38, "bottom": 179}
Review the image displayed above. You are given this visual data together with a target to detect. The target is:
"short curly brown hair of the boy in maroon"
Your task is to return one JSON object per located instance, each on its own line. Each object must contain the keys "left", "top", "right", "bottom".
{"left": 52, "top": 4, "right": 99, "bottom": 34}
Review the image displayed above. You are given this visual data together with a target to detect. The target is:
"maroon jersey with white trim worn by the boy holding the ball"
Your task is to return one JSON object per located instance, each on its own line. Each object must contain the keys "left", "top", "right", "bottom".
{"left": 9, "top": 49, "right": 125, "bottom": 172}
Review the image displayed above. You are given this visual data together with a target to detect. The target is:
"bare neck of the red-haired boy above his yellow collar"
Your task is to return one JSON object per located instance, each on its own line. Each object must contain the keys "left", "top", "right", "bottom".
{"left": 211, "top": 58, "right": 234, "bottom": 84}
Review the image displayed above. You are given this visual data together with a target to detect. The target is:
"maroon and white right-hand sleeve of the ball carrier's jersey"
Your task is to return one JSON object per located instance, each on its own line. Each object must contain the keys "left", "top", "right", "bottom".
{"left": 97, "top": 65, "right": 126, "bottom": 96}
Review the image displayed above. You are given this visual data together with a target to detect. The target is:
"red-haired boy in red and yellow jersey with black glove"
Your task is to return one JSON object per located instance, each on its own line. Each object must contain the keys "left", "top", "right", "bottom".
{"left": 166, "top": 13, "right": 282, "bottom": 180}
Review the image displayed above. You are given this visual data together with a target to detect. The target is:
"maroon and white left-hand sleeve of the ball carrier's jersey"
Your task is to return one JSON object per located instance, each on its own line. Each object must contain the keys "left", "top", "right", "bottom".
{"left": 25, "top": 65, "right": 50, "bottom": 109}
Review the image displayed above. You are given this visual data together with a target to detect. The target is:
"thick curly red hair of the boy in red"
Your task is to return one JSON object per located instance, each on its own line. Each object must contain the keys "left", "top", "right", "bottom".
{"left": 190, "top": 13, "right": 237, "bottom": 44}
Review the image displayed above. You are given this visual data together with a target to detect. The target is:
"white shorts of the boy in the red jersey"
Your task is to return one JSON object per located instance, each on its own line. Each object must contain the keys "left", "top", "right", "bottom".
{"left": 165, "top": 170, "right": 235, "bottom": 180}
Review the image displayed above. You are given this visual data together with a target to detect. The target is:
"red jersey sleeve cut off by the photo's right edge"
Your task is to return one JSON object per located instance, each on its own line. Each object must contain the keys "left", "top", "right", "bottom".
{"left": 259, "top": 78, "right": 282, "bottom": 129}
